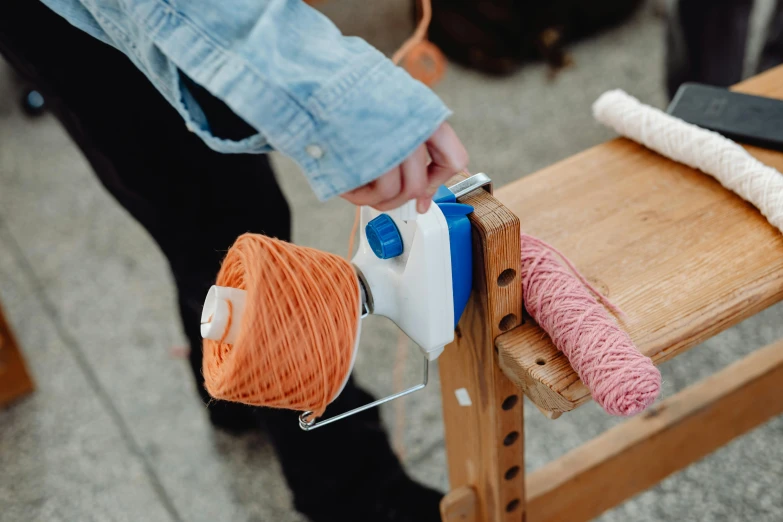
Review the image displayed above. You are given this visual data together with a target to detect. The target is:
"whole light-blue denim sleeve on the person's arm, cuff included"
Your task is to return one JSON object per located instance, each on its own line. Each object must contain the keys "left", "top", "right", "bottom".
{"left": 42, "top": 0, "right": 450, "bottom": 200}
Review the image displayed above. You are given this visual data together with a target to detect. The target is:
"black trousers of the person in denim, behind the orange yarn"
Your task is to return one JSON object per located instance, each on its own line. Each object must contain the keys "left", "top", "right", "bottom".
{"left": 0, "top": 0, "right": 420, "bottom": 520}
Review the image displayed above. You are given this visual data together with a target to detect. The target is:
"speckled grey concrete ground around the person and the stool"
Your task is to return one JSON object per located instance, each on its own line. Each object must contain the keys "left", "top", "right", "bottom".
{"left": 0, "top": 0, "right": 783, "bottom": 522}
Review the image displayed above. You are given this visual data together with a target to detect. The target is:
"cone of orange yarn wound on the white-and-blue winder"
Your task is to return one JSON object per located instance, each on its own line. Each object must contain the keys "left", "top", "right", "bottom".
{"left": 203, "top": 234, "right": 360, "bottom": 416}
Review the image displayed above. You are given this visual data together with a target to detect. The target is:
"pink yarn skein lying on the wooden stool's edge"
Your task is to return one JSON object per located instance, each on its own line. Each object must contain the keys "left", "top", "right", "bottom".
{"left": 522, "top": 234, "right": 661, "bottom": 416}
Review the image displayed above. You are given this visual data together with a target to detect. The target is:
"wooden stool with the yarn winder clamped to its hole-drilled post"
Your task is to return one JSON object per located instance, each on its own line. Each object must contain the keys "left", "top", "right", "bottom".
{"left": 440, "top": 67, "right": 783, "bottom": 522}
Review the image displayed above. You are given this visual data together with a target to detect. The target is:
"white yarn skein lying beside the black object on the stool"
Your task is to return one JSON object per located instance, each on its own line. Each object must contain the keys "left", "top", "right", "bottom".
{"left": 593, "top": 89, "right": 783, "bottom": 232}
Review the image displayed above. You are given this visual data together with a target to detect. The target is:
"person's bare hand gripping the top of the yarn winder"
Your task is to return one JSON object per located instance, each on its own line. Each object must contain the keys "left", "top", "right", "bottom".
{"left": 342, "top": 123, "right": 468, "bottom": 214}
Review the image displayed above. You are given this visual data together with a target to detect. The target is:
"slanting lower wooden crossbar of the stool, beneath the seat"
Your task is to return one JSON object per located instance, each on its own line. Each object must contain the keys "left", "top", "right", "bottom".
{"left": 526, "top": 340, "right": 783, "bottom": 522}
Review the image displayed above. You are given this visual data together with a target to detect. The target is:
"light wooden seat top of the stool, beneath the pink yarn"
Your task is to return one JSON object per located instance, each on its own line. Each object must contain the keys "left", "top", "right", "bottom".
{"left": 495, "top": 67, "right": 783, "bottom": 412}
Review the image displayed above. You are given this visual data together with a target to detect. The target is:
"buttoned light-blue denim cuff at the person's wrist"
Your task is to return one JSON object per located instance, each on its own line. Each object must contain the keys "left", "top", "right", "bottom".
{"left": 278, "top": 58, "right": 451, "bottom": 200}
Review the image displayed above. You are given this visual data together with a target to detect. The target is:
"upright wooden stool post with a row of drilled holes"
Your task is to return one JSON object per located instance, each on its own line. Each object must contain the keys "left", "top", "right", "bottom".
{"left": 439, "top": 186, "right": 525, "bottom": 522}
